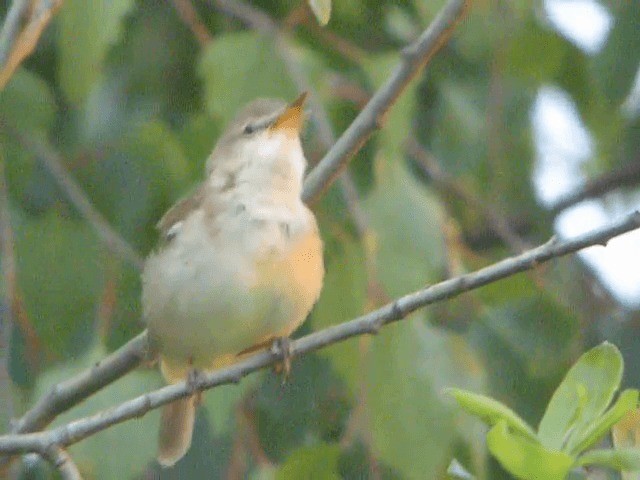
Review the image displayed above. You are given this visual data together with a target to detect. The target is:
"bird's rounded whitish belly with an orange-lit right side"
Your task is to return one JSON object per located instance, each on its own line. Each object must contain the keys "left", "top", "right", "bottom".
{"left": 143, "top": 218, "right": 323, "bottom": 382}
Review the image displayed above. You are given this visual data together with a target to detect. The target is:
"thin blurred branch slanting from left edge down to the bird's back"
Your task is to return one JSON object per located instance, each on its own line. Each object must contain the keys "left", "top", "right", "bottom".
{"left": 8, "top": 126, "right": 144, "bottom": 270}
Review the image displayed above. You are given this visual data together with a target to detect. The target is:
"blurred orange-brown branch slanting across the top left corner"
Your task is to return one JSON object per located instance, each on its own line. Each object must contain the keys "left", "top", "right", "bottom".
{"left": 0, "top": 0, "right": 62, "bottom": 90}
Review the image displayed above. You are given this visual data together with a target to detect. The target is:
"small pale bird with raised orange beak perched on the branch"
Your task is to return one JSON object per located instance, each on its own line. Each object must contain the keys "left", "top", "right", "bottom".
{"left": 142, "top": 93, "right": 324, "bottom": 467}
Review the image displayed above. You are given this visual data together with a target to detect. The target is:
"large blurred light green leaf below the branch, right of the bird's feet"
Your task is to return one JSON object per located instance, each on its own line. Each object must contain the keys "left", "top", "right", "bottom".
{"left": 365, "top": 318, "right": 460, "bottom": 480}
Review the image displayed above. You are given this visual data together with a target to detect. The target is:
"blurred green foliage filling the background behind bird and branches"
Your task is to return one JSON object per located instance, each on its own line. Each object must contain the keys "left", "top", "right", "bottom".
{"left": 0, "top": 0, "right": 640, "bottom": 480}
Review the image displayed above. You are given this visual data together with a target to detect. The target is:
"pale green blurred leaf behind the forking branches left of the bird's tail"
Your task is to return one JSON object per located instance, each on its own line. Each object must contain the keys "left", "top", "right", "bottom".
{"left": 34, "top": 345, "right": 162, "bottom": 480}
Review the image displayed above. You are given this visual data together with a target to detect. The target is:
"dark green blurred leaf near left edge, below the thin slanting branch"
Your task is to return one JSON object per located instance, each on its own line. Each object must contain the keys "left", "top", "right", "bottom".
{"left": 16, "top": 213, "right": 104, "bottom": 358}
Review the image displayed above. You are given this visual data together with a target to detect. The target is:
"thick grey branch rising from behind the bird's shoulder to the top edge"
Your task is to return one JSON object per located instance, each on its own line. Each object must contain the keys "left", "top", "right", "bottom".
{"left": 303, "top": 0, "right": 468, "bottom": 203}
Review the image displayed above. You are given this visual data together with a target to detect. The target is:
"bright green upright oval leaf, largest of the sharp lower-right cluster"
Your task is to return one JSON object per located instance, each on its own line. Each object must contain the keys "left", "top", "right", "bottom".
{"left": 538, "top": 342, "right": 624, "bottom": 449}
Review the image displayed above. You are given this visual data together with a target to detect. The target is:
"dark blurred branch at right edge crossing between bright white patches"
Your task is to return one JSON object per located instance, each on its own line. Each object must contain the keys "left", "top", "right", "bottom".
{"left": 551, "top": 157, "right": 640, "bottom": 215}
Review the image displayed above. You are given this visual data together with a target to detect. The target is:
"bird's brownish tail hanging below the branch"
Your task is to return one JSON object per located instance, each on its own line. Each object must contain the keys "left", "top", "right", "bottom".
{"left": 158, "top": 397, "right": 196, "bottom": 467}
